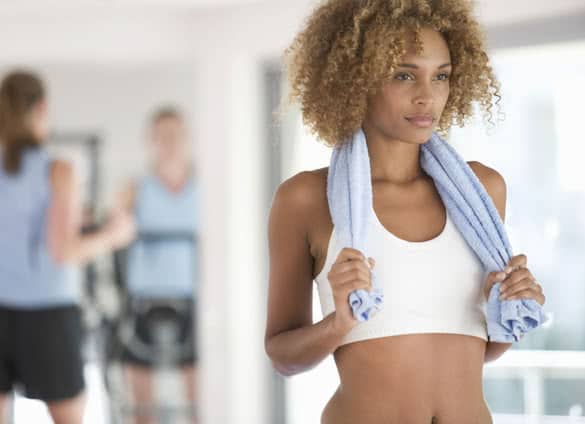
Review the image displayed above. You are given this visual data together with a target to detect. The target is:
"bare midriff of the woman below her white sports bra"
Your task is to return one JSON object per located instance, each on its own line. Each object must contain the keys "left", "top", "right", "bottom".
{"left": 321, "top": 334, "right": 492, "bottom": 424}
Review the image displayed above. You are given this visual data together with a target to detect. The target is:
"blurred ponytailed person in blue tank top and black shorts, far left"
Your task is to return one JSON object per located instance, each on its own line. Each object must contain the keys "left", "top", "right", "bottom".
{"left": 0, "top": 71, "right": 134, "bottom": 424}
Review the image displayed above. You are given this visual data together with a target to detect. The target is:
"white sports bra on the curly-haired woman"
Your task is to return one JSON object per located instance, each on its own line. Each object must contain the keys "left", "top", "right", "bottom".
{"left": 315, "top": 205, "right": 487, "bottom": 344}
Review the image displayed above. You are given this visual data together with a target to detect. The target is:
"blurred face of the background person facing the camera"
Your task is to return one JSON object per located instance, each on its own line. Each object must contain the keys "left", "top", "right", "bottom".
{"left": 151, "top": 117, "right": 189, "bottom": 165}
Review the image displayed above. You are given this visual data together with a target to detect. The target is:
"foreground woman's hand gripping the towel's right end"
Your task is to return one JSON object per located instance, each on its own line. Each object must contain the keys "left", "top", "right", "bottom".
{"left": 484, "top": 254, "right": 545, "bottom": 305}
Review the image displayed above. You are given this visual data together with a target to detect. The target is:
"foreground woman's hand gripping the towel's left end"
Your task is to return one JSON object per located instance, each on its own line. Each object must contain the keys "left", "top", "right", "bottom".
{"left": 327, "top": 247, "right": 375, "bottom": 335}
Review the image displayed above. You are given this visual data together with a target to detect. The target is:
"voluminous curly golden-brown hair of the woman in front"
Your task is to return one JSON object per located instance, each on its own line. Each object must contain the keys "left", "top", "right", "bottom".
{"left": 285, "top": 0, "right": 500, "bottom": 146}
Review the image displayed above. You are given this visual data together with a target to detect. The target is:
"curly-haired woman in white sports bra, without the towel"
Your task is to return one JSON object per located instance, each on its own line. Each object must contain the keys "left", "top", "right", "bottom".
{"left": 265, "top": 0, "right": 544, "bottom": 424}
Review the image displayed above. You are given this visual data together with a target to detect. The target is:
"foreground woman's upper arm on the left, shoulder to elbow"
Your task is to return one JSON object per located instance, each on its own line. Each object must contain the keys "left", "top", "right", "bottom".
{"left": 266, "top": 172, "right": 315, "bottom": 341}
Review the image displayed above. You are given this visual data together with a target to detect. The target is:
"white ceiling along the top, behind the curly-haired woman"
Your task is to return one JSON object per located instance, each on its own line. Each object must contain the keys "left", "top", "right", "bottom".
{"left": 0, "top": 0, "right": 585, "bottom": 64}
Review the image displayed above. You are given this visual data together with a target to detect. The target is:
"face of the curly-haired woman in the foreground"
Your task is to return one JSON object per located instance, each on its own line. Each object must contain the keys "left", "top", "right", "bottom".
{"left": 364, "top": 28, "right": 451, "bottom": 144}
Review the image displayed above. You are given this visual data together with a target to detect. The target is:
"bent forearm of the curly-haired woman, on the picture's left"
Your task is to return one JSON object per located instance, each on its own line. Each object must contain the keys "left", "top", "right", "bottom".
{"left": 266, "top": 312, "right": 346, "bottom": 376}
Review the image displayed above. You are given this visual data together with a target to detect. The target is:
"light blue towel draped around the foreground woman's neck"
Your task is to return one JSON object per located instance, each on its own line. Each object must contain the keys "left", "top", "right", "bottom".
{"left": 327, "top": 128, "right": 544, "bottom": 343}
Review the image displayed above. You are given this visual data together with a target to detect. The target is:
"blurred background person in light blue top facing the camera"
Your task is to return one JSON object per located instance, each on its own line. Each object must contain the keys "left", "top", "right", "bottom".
{"left": 115, "top": 107, "right": 199, "bottom": 423}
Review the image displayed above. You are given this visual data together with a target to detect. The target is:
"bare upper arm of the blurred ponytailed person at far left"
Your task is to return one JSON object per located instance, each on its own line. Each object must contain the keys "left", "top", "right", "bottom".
{"left": 47, "top": 160, "right": 81, "bottom": 262}
